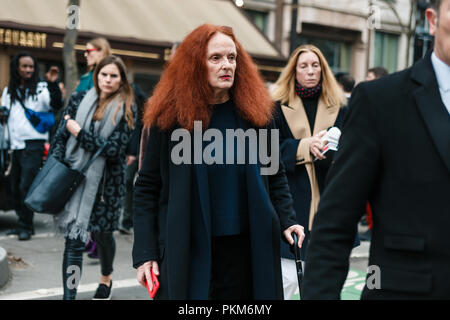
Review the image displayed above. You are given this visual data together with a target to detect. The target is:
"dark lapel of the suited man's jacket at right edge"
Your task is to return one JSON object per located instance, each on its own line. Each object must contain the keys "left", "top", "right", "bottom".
{"left": 411, "top": 55, "right": 450, "bottom": 171}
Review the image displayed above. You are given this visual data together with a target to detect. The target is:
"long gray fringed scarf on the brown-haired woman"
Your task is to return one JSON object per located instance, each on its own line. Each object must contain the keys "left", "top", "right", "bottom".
{"left": 55, "top": 88, "right": 124, "bottom": 243}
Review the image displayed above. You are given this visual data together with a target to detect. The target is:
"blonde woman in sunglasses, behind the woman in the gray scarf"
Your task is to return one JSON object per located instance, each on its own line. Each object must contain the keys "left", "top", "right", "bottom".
{"left": 75, "top": 37, "right": 111, "bottom": 92}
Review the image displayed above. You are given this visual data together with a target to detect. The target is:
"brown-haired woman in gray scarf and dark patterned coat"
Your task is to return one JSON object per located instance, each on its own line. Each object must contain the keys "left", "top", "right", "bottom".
{"left": 51, "top": 56, "right": 134, "bottom": 300}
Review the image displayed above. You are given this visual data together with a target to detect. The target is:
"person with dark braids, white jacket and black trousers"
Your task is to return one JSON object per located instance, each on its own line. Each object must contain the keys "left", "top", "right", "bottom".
{"left": 1, "top": 52, "right": 62, "bottom": 240}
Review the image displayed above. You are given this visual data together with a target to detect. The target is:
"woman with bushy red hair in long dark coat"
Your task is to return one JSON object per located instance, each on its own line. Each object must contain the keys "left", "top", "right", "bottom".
{"left": 133, "top": 24, "right": 304, "bottom": 300}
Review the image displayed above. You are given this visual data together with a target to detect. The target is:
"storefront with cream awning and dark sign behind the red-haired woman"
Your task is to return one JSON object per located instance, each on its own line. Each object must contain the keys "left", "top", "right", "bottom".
{"left": 0, "top": 0, "right": 286, "bottom": 94}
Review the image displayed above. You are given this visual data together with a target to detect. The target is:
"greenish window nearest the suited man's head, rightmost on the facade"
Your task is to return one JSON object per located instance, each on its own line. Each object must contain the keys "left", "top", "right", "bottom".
{"left": 373, "top": 32, "right": 399, "bottom": 73}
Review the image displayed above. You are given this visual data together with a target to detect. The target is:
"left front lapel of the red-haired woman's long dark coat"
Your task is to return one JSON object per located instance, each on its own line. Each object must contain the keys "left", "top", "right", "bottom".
{"left": 166, "top": 135, "right": 211, "bottom": 299}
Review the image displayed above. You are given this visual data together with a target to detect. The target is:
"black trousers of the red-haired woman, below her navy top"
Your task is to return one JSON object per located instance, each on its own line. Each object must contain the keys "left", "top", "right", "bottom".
{"left": 209, "top": 235, "right": 253, "bottom": 300}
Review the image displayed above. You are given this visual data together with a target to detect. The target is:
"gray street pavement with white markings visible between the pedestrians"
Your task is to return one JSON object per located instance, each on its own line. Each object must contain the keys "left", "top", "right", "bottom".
{"left": 0, "top": 211, "right": 369, "bottom": 300}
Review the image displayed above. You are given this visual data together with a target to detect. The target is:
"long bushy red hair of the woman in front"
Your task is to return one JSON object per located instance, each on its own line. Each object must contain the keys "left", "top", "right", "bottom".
{"left": 143, "top": 24, "right": 274, "bottom": 130}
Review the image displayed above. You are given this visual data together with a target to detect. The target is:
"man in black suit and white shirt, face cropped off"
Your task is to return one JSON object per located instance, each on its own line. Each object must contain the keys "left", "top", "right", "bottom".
{"left": 302, "top": 0, "right": 450, "bottom": 299}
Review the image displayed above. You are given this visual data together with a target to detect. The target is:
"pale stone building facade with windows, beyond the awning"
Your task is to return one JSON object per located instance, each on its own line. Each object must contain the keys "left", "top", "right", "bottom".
{"left": 242, "top": 0, "right": 430, "bottom": 82}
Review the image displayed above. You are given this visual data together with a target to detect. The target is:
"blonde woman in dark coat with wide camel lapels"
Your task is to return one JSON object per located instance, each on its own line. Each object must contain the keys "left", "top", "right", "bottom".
{"left": 272, "top": 45, "right": 352, "bottom": 299}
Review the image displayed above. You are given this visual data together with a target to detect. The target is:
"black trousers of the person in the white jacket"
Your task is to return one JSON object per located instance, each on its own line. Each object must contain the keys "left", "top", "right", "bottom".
{"left": 10, "top": 140, "right": 45, "bottom": 231}
